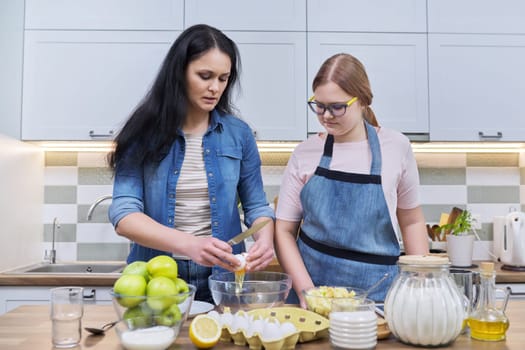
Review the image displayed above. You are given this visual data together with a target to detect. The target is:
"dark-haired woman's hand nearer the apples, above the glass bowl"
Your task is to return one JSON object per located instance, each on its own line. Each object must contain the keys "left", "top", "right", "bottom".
{"left": 186, "top": 237, "right": 240, "bottom": 271}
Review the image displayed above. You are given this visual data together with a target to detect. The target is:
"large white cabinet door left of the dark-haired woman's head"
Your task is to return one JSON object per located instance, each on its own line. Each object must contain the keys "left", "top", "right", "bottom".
{"left": 22, "top": 31, "right": 178, "bottom": 140}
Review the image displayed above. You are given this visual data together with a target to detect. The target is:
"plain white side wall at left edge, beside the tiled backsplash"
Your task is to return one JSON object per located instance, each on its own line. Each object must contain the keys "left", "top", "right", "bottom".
{"left": 0, "top": 134, "right": 44, "bottom": 271}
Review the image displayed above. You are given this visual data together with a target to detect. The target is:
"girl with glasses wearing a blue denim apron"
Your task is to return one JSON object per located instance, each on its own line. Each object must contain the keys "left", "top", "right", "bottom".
{"left": 275, "top": 54, "right": 428, "bottom": 307}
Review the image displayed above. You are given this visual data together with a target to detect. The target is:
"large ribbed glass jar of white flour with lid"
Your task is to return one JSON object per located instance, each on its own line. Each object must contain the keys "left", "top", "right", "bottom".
{"left": 385, "top": 255, "right": 468, "bottom": 347}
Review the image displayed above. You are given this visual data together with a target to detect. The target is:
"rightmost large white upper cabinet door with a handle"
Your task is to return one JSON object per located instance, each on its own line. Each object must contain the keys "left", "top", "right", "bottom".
{"left": 429, "top": 34, "right": 525, "bottom": 141}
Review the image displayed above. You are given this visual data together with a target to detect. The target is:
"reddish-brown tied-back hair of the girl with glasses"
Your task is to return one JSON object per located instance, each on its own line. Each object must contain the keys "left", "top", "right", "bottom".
{"left": 312, "top": 53, "right": 379, "bottom": 126}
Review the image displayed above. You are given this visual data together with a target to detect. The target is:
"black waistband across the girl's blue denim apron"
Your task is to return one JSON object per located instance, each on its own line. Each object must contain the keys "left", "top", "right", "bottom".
{"left": 299, "top": 230, "right": 399, "bottom": 265}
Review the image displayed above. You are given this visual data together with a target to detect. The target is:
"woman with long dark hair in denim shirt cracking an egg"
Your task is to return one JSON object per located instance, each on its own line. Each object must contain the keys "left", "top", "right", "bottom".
{"left": 109, "top": 25, "right": 274, "bottom": 302}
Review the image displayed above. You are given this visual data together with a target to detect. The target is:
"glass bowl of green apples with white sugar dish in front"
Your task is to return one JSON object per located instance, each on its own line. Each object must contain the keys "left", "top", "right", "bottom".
{"left": 111, "top": 255, "right": 196, "bottom": 350}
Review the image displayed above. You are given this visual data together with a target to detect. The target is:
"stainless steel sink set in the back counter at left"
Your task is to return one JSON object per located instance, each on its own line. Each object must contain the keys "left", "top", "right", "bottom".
{"left": 6, "top": 262, "right": 126, "bottom": 274}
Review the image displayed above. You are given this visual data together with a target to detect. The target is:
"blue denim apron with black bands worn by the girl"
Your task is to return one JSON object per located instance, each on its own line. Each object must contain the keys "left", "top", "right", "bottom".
{"left": 290, "top": 122, "right": 400, "bottom": 302}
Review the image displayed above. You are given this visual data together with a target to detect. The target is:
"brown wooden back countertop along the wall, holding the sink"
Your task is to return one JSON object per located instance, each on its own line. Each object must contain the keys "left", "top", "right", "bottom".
{"left": 0, "top": 259, "right": 525, "bottom": 287}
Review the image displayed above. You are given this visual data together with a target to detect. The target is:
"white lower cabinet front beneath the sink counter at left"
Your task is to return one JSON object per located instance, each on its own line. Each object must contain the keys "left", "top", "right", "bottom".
{"left": 0, "top": 286, "right": 111, "bottom": 315}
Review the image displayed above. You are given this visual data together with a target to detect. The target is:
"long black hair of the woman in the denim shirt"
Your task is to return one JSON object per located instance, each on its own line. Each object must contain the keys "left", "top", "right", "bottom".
{"left": 108, "top": 24, "right": 240, "bottom": 170}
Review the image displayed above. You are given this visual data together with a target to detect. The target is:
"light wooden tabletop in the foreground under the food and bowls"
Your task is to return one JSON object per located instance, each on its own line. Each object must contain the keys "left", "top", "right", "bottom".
{"left": 0, "top": 300, "right": 525, "bottom": 350}
